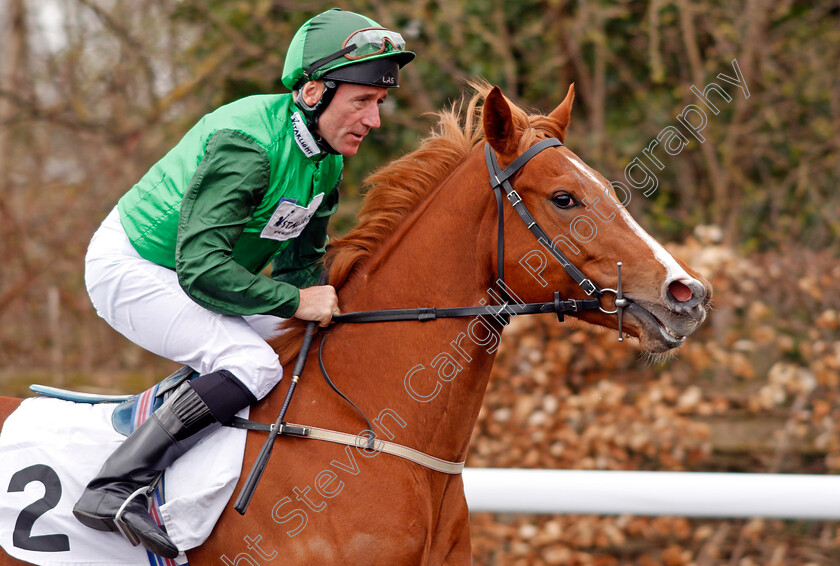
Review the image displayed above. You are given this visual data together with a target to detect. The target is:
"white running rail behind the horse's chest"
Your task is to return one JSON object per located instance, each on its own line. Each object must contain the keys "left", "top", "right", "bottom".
{"left": 463, "top": 468, "right": 840, "bottom": 520}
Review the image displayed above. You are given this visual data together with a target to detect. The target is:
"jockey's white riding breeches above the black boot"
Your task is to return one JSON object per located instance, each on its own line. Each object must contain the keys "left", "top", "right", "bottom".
{"left": 85, "top": 207, "right": 283, "bottom": 399}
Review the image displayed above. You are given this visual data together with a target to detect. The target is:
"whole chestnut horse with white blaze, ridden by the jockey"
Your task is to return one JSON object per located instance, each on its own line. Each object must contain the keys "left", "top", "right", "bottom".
{"left": 0, "top": 85, "right": 711, "bottom": 566}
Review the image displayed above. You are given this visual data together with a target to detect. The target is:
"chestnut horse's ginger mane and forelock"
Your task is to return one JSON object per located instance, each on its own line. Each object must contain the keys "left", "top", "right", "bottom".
{"left": 270, "top": 82, "right": 549, "bottom": 364}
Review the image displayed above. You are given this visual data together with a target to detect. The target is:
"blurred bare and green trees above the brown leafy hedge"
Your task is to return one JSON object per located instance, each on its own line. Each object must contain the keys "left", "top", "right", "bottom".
{"left": 0, "top": 0, "right": 840, "bottom": 380}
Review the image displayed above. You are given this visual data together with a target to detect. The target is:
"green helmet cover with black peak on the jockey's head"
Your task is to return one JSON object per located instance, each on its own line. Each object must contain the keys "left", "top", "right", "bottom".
{"left": 282, "top": 8, "right": 414, "bottom": 90}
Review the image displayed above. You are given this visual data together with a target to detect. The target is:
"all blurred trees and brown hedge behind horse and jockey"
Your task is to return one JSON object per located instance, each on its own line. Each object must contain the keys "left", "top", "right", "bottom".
{"left": 0, "top": 0, "right": 840, "bottom": 566}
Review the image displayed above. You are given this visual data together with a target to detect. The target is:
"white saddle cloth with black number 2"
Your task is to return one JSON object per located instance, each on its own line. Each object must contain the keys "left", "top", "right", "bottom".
{"left": 0, "top": 398, "right": 248, "bottom": 566}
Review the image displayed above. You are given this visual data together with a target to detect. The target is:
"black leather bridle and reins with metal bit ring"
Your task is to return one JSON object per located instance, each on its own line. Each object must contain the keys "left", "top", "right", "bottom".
{"left": 332, "top": 138, "right": 630, "bottom": 342}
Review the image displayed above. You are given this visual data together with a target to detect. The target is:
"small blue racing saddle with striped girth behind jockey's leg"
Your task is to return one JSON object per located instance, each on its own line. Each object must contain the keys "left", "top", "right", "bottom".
{"left": 29, "top": 366, "right": 198, "bottom": 436}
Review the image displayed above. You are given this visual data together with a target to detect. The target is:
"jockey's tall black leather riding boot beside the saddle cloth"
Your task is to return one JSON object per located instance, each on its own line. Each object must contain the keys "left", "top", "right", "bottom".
{"left": 73, "top": 370, "right": 256, "bottom": 558}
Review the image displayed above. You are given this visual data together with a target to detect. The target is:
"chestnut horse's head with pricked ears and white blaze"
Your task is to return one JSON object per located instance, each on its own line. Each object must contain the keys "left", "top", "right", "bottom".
{"left": 483, "top": 86, "right": 712, "bottom": 352}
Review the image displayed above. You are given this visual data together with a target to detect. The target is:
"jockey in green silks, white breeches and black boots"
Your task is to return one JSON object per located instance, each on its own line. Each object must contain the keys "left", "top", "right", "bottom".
{"left": 73, "top": 9, "right": 414, "bottom": 558}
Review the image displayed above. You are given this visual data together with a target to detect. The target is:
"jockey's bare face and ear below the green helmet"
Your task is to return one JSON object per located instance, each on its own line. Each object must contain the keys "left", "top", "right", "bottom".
{"left": 302, "top": 81, "right": 388, "bottom": 157}
